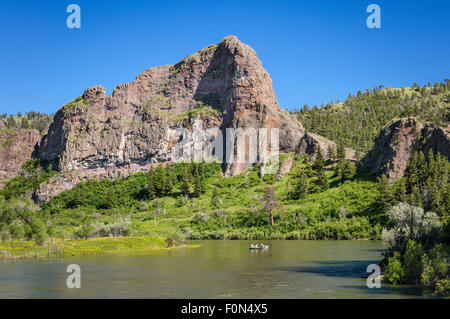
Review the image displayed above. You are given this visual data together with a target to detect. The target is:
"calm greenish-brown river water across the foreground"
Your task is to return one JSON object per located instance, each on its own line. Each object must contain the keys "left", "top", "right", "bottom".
{"left": 0, "top": 240, "right": 428, "bottom": 298}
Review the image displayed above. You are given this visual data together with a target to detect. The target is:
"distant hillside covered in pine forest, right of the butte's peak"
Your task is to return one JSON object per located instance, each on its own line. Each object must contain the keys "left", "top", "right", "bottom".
{"left": 294, "top": 79, "right": 450, "bottom": 152}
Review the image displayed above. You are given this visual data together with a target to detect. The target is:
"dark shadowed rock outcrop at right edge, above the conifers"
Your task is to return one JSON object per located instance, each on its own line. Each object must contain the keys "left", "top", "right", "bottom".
{"left": 362, "top": 118, "right": 450, "bottom": 183}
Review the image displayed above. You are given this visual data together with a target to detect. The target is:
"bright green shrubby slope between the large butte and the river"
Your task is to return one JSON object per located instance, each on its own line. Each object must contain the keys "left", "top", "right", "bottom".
{"left": 0, "top": 154, "right": 382, "bottom": 245}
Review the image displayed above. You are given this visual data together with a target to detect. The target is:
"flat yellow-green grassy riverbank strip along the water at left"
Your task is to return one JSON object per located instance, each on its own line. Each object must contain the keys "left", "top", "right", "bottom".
{"left": 0, "top": 236, "right": 194, "bottom": 259}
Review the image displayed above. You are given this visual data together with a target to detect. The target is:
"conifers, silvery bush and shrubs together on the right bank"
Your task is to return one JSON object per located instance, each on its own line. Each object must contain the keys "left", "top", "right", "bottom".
{"left": 378, "top": 152, "right": 450, "bottom": 295}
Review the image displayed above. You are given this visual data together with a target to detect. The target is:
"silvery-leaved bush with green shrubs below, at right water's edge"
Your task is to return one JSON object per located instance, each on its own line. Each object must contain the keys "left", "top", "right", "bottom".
{"left": 383, "top": 203, "right": 450, "bottom": 295}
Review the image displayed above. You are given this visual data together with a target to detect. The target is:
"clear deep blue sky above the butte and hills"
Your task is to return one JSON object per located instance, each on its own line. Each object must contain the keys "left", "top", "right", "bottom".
{"left": 0, "top": 0, "right": 450, "bottom": 114}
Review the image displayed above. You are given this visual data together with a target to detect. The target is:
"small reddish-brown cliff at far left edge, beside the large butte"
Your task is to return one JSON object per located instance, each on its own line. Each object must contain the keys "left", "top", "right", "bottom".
{"left": 0, "top": 128, "right": 41, "bottom": 180}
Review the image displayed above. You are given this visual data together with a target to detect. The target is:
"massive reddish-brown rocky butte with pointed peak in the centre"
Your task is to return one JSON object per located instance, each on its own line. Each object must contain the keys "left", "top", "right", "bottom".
{"left": 34, "top": 36, "right": 352, "bottom": 201}
